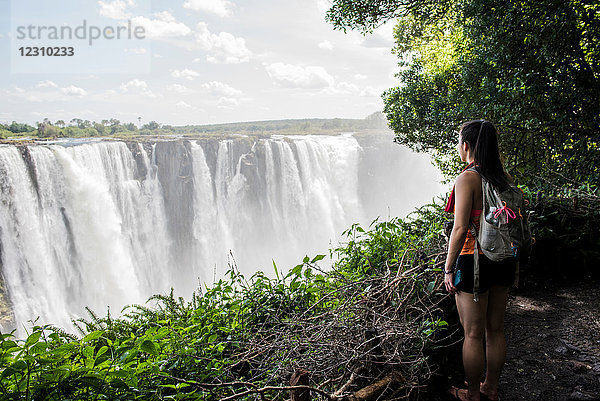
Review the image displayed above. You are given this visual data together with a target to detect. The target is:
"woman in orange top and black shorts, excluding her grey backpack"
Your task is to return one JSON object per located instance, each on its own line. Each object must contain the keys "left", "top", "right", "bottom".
{"left": 444, "top": 120, "right": 515, "bottom": 401}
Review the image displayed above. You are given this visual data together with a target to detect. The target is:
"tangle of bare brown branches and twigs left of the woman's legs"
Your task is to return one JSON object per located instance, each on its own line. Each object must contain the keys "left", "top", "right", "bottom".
{"left": 217, "top": 248, "right": 454, "bottom": 398}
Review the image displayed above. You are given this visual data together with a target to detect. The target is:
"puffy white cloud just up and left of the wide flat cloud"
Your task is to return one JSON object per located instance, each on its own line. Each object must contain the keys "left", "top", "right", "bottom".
{"left": 195, "top": 22, "right": 251, "bottom": 64}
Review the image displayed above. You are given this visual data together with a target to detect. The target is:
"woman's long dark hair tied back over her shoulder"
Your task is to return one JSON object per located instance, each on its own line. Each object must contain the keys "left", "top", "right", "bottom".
{"left": 460, "top": 120, "right": 510, "bottom": 191}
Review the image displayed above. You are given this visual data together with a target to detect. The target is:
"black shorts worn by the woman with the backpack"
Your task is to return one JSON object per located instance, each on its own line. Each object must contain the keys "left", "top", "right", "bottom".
{"left": 454, "top": 254, "right": 517, "bottom": 294}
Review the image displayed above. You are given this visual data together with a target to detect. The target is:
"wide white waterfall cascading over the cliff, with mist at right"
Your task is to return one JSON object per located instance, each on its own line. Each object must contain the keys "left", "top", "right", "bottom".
{"left": 0, "top": 134, "right": 440, "bottom": 332}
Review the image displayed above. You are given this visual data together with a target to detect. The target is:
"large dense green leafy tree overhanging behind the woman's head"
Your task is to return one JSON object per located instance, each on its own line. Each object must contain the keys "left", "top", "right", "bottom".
{"left": 326, "top": 0, "right": 600, "bottom": 185}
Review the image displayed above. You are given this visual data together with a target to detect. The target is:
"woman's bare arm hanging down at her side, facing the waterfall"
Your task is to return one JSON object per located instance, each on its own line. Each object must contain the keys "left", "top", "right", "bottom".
{"left": 444, "top": 171, "right": 478, "bottom": 294}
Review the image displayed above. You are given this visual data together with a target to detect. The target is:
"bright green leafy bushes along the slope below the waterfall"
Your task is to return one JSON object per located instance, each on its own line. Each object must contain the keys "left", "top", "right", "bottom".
{"left": 0, "top": 205, "right": 446, "bottom": 400}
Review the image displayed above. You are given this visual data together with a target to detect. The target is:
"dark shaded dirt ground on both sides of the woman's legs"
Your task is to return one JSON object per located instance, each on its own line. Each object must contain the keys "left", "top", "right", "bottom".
{"left": 423, "top": 274, "right": 600, "bottom": 401}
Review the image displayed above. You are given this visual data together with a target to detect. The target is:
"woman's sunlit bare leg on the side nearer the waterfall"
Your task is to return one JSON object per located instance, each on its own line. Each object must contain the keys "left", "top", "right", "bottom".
{"left": 456, "top": 292, "right": 488, "bottom": 401}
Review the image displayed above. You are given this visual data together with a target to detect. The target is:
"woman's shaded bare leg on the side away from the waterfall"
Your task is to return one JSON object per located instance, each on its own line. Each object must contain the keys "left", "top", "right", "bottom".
{"left": 481, "top": 286, "right": 508, "bottom": 399}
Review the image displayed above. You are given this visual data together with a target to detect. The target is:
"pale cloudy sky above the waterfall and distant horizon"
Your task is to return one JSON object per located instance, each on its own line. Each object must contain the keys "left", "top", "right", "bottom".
{"left": 0, "top": 0, "right": 398, "bottom": 125}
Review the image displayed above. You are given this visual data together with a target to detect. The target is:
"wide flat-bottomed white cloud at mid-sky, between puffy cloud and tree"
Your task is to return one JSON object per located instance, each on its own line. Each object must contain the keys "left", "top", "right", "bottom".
{"left": 265, "top": 63, "right": 334, "bottom": 88}
